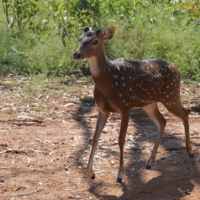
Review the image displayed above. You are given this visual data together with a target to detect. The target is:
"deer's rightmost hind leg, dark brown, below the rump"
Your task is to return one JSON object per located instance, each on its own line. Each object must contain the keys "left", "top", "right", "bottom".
{"left": 164, "top": 102, "right": 193, "bottom": 158}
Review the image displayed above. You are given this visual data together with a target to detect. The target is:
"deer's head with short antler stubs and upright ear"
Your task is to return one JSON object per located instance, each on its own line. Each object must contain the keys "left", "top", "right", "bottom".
{"left": 73, "top": 26, "right": 115, "bottom": 60}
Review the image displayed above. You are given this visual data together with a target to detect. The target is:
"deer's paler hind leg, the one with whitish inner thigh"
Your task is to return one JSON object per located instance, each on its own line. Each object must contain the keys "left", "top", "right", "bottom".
{"left": 143, "top": 103, "right": 166, "bottom": 169}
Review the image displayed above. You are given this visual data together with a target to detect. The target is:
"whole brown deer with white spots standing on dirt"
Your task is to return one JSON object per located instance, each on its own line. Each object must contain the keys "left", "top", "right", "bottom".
{"left": 73, "top": 26, "right": 193, "bottom": 182}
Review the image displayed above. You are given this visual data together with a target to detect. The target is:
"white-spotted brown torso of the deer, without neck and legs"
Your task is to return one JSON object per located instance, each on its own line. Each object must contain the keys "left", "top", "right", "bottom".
{"left": 94, "top": 58, "right": 180, "bottom": 111}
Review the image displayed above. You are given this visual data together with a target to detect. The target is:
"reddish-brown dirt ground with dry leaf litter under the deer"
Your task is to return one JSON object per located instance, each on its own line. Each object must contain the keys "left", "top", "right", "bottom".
{"left": 0, "top": 77, "right": 200, "bottom": 200}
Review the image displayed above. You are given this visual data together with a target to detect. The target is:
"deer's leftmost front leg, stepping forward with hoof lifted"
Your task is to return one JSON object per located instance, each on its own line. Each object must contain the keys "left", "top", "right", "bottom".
{"left": 87, "top": 111, "right": 110, "bottom": 179}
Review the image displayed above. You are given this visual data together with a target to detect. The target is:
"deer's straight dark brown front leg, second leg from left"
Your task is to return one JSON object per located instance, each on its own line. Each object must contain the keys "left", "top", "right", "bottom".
{"left": 117, "top": 111, "right": 130, "bottom": 183}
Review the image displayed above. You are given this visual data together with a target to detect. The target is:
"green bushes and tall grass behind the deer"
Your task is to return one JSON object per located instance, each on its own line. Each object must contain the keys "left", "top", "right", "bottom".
{"left": 0, "top": 0, "right": 200, "bottom": 80}
